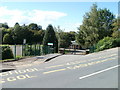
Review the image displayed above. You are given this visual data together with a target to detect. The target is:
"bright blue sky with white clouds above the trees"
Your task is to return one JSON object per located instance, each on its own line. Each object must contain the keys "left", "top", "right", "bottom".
{"left": 0, "top": 2, "right": 118, "bottom": 32}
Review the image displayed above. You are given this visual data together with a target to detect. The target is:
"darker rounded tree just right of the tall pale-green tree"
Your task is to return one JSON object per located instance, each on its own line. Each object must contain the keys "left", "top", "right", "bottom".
{"left": 98, "top": 8, "right": 115, "bottom": 40}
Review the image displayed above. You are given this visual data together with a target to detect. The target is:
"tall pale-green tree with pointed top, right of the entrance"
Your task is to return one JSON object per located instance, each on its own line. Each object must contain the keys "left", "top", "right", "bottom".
{"left": 77, "top": 4, "right": 99, "bottom": 48}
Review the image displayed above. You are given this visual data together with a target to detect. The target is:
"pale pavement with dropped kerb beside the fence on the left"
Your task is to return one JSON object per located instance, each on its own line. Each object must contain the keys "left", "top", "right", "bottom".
{"left": 0, "top": 54, "right": 61, "bottom": 72}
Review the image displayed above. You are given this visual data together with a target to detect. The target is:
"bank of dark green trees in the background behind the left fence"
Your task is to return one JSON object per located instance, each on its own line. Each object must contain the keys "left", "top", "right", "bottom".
{"left": 1, "top": 23, "right": 45, "bottom": 44}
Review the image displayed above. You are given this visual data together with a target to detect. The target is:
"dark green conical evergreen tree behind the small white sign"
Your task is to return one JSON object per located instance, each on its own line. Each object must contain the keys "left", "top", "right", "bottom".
{"left": 43, "top": 25, "right": 58, "bottom": 53}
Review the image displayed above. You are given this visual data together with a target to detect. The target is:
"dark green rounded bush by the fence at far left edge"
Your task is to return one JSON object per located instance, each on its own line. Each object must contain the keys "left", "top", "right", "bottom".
{"left": 2, "top": 46, "right": 14, "bottom": 60}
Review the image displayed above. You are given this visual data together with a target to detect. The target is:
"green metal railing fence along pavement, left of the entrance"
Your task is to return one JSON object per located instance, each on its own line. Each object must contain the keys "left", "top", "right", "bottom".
{"left": 4, "top": 44, "right": 54, "bottom": 59}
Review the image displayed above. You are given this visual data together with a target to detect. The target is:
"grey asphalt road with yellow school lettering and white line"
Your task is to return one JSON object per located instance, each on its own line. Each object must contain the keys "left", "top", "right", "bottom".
{"left": 0, "top": 48, "right": 119, "bottom": 88}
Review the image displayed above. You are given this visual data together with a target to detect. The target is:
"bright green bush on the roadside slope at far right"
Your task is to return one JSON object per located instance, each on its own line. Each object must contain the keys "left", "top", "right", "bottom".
{"left": 95, "top": 37, "right": 120, "bottom": 51}
